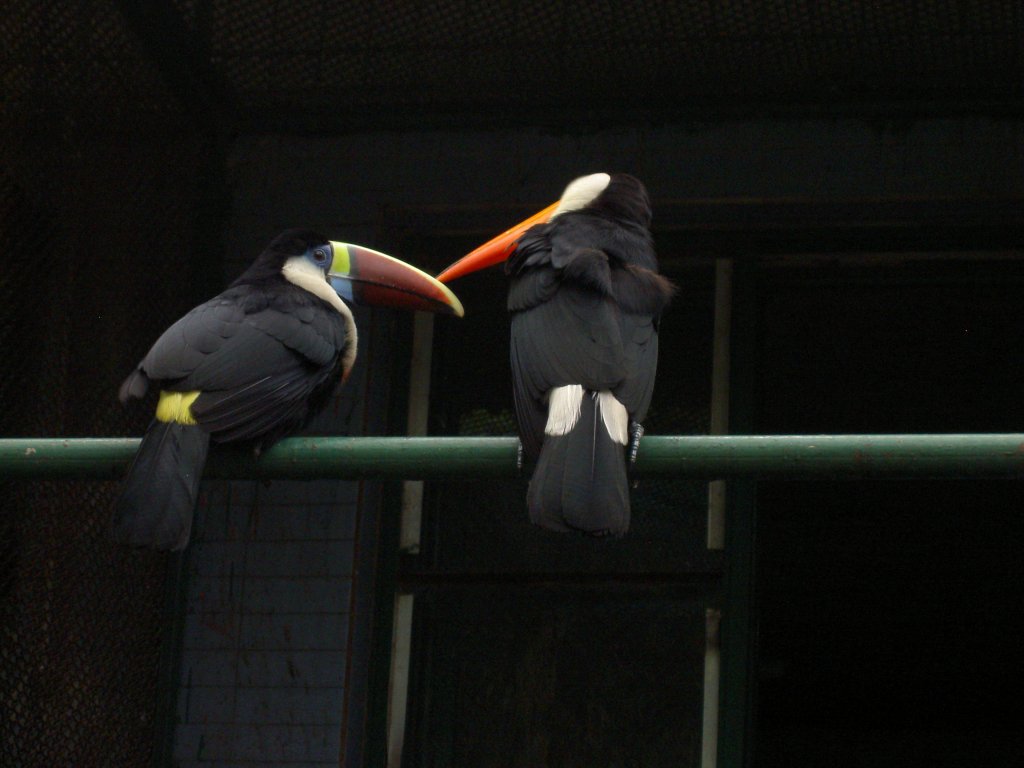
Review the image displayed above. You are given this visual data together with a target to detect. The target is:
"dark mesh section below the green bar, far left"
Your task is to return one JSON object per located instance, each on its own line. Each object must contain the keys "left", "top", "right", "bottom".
{"left": 0, "top": 482, "right": 164, "bottom": 766}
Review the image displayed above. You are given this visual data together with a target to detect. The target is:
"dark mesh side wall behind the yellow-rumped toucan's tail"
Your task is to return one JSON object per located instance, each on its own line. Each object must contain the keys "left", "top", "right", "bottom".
{"left": 0, "top": 0, "right": 211, "bottom": 768}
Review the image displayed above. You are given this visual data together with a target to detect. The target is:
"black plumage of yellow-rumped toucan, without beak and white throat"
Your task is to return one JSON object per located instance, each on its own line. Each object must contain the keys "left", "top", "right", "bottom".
{"left": 113, "top": 230, "right": 354, "bottom": 550}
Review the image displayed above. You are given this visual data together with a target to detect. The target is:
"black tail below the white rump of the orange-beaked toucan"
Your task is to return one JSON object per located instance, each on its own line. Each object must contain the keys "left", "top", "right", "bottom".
{"left": 526, "top": 392, "right": 630, "bottom": 536}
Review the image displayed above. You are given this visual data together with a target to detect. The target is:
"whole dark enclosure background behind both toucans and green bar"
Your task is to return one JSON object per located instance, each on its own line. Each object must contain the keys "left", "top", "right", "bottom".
{"left": 0, "top": 0, "right": 1024, "bottom": 766}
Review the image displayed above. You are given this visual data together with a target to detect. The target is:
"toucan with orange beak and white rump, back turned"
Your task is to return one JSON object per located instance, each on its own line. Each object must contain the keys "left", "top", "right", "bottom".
{"left": 437, "top": 173, "right": 675, "bottom": 537}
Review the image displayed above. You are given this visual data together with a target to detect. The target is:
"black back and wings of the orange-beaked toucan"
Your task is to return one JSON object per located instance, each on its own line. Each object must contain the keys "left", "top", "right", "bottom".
{"left": 508, "top": 223, "right": 672, "bottom": 456}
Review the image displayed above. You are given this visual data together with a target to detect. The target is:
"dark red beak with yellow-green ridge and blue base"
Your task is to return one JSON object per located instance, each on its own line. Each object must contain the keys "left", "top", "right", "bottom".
{"left": 328, "top": 241, "right": 464, "bottom": 317}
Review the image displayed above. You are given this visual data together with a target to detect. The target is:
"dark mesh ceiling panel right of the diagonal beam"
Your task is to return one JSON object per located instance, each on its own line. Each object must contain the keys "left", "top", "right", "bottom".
{"left": 210, "top": 0, "right": 1024, "bottom": 119}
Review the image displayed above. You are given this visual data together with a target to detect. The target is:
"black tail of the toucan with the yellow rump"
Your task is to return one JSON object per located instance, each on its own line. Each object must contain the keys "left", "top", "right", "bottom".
{"left": 111, "top": 421, "right": 210, "bottom": 550}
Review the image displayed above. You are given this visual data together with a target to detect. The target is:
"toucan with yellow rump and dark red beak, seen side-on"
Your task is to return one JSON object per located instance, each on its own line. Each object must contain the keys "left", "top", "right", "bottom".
{"left": 113, "top": 229, "right": 463, "bottom": 550}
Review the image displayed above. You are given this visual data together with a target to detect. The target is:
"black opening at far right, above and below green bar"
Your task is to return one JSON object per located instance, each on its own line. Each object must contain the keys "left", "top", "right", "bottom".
{"left": 756, "top": 261, "right": 1024, "bottom": 766}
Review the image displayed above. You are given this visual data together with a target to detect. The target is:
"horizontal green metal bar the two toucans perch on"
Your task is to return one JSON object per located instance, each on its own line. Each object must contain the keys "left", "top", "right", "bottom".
{"left": 6, "top": 433, "right": 1024, "bottom": 479}
